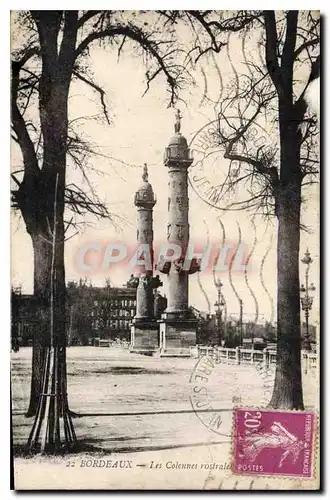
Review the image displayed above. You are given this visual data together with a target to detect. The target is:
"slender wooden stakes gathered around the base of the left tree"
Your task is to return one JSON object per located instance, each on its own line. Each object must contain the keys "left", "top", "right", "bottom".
{"left": 28, "top": 173, "right": 76, "bottom": 453}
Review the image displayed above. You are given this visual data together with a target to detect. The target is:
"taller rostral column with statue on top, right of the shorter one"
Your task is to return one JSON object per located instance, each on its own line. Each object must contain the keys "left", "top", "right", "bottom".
{"left": 157, "top": 111, "right": 199, "bottom": 357}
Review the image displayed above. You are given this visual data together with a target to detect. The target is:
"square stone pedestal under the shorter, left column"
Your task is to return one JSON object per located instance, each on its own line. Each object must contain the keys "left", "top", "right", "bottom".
{"left": 130, "top": 319, "right": 159, "bottom": 356}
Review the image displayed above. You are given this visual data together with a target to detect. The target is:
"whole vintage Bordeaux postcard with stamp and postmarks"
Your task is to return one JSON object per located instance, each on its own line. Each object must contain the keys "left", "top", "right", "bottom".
{"left": 11, "top": 10, "right": 321, "bottom": 491}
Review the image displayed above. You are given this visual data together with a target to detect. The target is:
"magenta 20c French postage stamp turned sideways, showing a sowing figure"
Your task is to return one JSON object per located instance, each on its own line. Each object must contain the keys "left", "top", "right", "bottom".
{"left": 232, "top": 408, "right": 316, "bottom": 478}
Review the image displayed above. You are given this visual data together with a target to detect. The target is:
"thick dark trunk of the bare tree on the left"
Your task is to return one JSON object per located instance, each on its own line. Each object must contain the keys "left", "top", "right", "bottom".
{"left": 22, "top": 11, "right": 78, "bottom": 422}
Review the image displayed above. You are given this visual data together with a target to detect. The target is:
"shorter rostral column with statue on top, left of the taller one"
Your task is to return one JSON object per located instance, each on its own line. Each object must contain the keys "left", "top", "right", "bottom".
{"left": 130, "top": 164, "right": 162, "bottom": 355}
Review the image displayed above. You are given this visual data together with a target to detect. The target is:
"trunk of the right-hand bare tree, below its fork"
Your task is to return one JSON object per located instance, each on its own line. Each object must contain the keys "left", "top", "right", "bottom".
{"left": 270, "top": 114, "right": 303, "bottom": 409}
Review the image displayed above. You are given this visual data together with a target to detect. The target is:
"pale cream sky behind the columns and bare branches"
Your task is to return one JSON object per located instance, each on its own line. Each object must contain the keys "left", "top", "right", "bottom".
{"left": 11, "top": 13, "right": 319, "bottom": 322}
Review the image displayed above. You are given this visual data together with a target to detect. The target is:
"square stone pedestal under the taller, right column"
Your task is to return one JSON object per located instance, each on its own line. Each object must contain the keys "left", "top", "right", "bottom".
{"left": 159, "top": 313, "right": 197, "bottom": 358}
